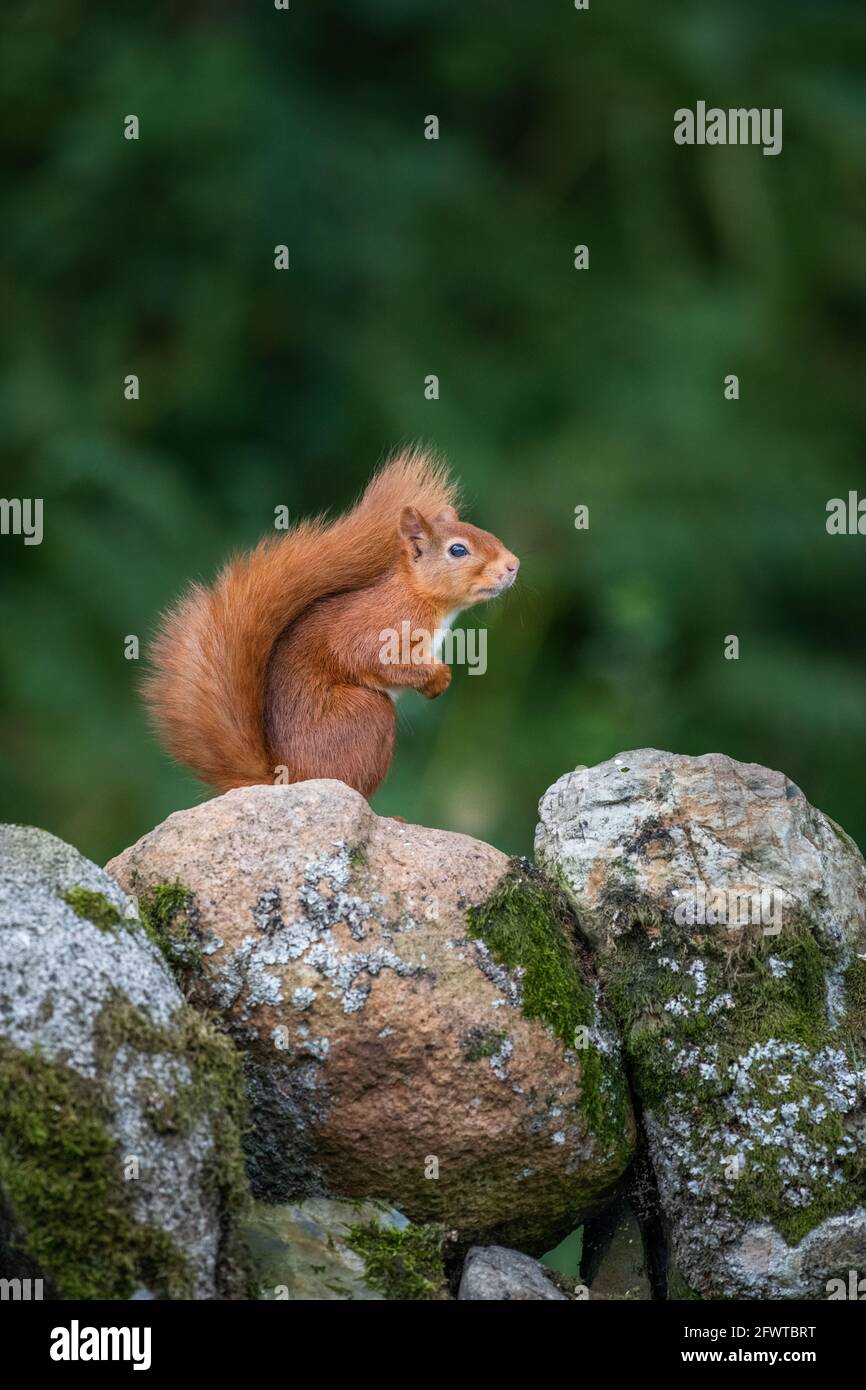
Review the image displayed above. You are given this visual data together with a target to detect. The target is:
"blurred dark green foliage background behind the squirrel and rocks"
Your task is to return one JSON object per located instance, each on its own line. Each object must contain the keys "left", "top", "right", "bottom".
{"left": 0, "top": 0, "right": 866, "bottom": 859}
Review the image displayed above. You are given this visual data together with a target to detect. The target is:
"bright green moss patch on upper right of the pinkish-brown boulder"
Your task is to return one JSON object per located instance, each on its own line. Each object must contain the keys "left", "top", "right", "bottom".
{"left": 467, "top": 860, "right": 595, "bottom": 1047}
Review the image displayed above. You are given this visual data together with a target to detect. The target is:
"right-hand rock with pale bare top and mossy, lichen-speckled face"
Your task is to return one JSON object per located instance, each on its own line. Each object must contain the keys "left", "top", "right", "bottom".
{"left": 537, "top": 751, "right": 866, "bottom": 1298}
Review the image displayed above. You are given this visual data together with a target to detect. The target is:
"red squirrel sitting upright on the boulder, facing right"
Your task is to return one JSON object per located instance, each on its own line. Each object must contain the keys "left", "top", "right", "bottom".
{"left": 146, "top": 450, "right": 520, "bottom": 796}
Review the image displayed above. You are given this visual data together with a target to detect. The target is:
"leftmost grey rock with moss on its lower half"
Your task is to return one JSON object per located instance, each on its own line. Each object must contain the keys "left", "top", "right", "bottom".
{"left": 0, "top": 827, "right": 249, "bottom": 1298}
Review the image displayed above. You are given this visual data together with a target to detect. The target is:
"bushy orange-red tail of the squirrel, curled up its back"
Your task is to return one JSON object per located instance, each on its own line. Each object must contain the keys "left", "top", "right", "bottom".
{"left": 145, "top": 449, "right": 456, "bottom": 791}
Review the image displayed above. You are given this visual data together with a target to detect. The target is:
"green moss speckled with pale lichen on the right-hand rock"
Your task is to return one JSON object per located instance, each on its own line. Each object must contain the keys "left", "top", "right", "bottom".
{"left": 607, "top": 923, "right": 866, "bottom": 1243}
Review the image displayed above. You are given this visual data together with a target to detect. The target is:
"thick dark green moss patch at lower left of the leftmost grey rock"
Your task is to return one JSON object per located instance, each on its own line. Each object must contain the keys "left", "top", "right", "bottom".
{"left": 0, "top": 1041, "right": 190, "bottom": 1298}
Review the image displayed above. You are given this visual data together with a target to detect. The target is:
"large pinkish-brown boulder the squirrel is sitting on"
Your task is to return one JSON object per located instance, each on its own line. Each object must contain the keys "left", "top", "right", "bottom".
{"left": 108, "top": 781, "right": 632, "bottom": 1252}
